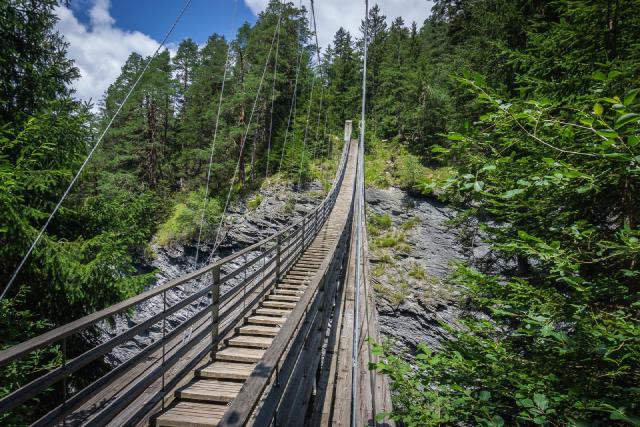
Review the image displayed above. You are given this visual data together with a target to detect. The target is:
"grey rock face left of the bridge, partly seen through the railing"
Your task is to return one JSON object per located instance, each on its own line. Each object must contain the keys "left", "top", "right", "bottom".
{"left": 104, "top": 182, "right": 324, "bottom": 366}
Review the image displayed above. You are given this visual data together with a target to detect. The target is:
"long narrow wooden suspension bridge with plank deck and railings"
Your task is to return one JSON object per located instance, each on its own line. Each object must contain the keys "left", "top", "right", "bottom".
{"left": 0, "top": 122, "right": 390, "bottom": 426}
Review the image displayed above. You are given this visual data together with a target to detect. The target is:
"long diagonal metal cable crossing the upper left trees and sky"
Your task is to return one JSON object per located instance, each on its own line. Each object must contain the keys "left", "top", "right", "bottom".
{"left": 0, "top": 0, "right": 192, "bottom": 301}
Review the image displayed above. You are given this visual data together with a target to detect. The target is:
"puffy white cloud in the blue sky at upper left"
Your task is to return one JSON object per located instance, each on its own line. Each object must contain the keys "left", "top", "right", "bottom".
{"left": 56, "top": 0, "right": 158, "bottom": 104}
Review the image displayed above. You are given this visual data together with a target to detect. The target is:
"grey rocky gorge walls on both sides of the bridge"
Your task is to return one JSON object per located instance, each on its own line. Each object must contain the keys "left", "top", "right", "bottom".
{"left": 100, "top": 182, "right": 478, "bottom": 366}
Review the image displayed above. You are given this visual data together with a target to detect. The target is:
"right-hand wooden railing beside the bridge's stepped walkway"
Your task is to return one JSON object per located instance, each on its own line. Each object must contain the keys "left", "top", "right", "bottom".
{"left": 218, "top": 139, "right": 353, "bottom": 426}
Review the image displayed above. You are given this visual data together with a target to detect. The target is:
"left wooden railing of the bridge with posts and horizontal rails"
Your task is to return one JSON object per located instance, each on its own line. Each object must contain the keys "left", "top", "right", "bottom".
{"left": 0, "top": 135, "right": 348, "bottom": 426}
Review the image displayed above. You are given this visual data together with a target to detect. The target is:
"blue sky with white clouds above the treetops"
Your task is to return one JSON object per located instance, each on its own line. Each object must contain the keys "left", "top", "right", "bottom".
{"left": 56, "top": 0, "right": 432, "bottom": 104}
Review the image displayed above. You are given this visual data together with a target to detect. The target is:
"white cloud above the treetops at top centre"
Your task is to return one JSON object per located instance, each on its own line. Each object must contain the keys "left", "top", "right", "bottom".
{"left": 245, "top": 0, "right": 433, "bottom": 47}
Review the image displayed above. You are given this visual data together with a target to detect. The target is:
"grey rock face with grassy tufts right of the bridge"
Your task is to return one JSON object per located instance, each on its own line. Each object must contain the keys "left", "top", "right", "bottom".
{"left": 366, "top": 188, "right": 486, "bottom": 354}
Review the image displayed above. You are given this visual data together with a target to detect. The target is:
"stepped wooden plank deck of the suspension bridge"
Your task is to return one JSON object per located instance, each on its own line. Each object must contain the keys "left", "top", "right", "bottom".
{"left": 151, "top": 141, "right": 357, "bottom": 427}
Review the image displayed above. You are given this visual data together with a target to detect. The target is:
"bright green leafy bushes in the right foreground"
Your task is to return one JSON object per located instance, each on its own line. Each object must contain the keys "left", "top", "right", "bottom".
{"left": 377, "top": 78, "right": 640, "bottom": 425}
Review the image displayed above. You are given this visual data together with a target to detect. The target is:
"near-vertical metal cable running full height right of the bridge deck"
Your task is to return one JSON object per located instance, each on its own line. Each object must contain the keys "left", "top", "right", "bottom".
{"left": 351, "top": 0, "right": 375, "bottom": 426}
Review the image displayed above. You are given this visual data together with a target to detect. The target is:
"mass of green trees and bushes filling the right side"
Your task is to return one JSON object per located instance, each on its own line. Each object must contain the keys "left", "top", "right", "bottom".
{"left": 367, "top": 0, "right": 640, "bottom": 426}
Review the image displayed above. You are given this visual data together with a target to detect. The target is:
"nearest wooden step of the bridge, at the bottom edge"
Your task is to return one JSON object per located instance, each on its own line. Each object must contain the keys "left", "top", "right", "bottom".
{"left": 155, "top": 402, "right": 227, "bottom": 427}
